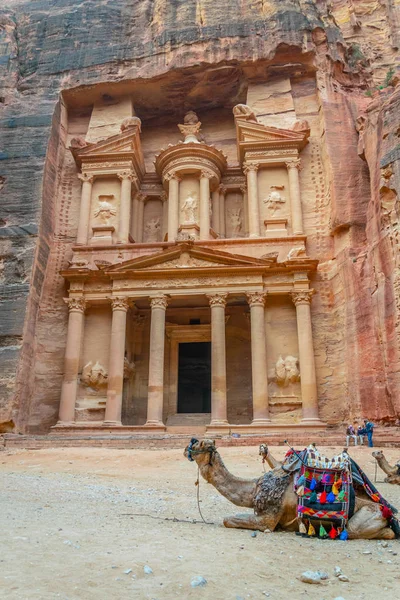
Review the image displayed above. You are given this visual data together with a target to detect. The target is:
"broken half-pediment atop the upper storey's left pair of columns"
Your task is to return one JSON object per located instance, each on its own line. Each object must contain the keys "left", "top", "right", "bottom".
{"left": 70, "top": 119, "right": 145, "bottom": 179}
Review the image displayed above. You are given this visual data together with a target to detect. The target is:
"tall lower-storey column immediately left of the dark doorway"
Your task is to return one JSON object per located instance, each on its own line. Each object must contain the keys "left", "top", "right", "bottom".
{"left": 146, "top": 294, "right": 168, "bottom": 427}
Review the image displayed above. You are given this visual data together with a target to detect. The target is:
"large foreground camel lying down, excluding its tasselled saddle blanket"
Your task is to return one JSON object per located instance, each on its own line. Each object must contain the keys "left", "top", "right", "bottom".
{"left": 184, "top": 439, "right": 395, "bottom": 540}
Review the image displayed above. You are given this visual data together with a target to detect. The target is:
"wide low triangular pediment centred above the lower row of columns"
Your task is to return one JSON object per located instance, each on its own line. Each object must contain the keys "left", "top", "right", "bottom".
{"left": 107, "top": 243, "right": 276, "bottom": 276}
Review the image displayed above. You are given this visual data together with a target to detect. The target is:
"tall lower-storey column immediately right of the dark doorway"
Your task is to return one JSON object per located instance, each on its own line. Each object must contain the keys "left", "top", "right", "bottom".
{"left": 207, "top": 293, "right": 228, "bottom": 427}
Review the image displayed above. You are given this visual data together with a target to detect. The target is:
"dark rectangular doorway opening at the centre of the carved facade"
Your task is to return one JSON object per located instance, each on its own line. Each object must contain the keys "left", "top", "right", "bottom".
{"left": 178, "top": 342, "right": 211, "bottom": 413}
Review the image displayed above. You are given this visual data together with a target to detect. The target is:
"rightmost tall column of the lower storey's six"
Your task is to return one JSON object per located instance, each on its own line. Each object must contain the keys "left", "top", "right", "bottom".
{"left": 291, "top": 290, "right": 320, "bottom": 423}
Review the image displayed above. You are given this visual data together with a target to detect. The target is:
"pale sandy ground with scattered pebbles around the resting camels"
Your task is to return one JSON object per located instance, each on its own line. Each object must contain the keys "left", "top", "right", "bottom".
{"left": 0, "top": 447, "right": 400, "bottom": 600}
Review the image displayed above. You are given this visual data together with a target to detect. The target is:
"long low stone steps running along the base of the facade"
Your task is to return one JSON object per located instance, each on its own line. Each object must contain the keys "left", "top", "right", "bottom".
{"left": 0, "top": 427, "right": 400, "bottom": 450}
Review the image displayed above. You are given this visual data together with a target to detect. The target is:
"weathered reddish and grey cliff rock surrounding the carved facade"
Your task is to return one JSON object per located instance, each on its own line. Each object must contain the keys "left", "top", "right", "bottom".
{"left": 0, "top": 0, "right": 400, "bottom": 431}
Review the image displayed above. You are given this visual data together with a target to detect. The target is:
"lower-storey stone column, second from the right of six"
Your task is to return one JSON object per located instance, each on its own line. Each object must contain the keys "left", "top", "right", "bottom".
{"left": 247, "top": 292, "right": 270, "bottom": 425}
